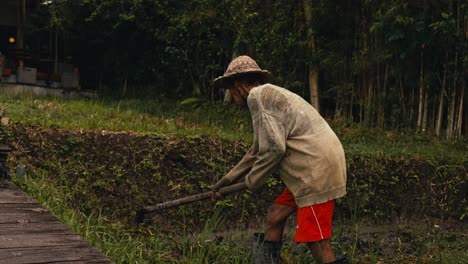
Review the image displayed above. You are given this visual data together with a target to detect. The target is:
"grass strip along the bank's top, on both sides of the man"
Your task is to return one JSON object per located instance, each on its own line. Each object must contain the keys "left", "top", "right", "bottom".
{"left": 0, "top": 95, "right": 468, "bottom": 164}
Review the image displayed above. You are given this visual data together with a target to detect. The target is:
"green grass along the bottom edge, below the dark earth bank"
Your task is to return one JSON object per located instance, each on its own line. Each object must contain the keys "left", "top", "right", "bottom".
{"left": 14, "top": 170, "right": 468, "bottom": 264}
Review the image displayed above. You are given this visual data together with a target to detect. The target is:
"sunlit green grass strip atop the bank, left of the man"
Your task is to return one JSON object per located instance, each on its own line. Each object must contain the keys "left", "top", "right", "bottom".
{"left": 0, "top": 95, "right": 251, "bottom": 140}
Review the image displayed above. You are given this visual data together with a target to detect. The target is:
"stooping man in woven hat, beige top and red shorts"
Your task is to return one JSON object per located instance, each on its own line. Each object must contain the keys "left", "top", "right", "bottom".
{"left": 213, "top": 56, "right": 347, "bottom": 263}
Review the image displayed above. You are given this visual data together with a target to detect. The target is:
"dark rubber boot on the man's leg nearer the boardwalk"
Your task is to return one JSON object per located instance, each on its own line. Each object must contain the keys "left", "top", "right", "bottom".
{"left": 252, "top": 233, "right": 282, "bottom": 264}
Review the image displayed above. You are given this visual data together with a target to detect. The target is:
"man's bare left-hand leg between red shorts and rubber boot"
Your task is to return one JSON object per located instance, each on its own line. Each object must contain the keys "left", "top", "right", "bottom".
{"left": 265, "top": 204, "right": 296, "bottom": 241}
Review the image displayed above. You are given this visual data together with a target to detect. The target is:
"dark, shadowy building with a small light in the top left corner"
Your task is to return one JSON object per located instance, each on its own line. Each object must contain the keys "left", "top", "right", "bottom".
{"left": 0, "top": 0, "right": 79, "bottom": 88}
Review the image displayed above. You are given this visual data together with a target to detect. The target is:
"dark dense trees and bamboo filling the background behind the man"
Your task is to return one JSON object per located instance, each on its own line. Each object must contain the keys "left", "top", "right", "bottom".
{"left": 28, "top": 0, "right": 468, "bottom": 138}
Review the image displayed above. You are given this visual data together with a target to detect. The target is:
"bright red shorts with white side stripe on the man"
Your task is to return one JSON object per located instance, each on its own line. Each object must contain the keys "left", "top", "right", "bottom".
{"left": 275, "top": 188, "right": 335, "bottom": 243}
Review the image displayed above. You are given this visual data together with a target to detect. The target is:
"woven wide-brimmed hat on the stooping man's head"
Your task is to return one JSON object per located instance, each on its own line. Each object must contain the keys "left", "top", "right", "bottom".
{"left": 214, "top": 55, "right": 273, "bottom": 87}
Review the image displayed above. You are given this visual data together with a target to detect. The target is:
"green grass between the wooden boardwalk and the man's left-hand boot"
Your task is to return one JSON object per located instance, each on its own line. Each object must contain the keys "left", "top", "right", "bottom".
{"left": 13, "top": 170, "right": 256, "bottom": 263}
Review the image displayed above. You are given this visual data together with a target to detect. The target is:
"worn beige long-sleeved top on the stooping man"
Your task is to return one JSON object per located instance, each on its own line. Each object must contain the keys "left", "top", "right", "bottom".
{"left": 216, "top": 84, "right": 346, "bottom": 207}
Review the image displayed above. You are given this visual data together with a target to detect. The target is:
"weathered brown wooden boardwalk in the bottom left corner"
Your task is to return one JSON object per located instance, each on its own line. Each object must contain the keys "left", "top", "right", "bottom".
{"left": 0, "top": 178, "right": 112, "bottom": 264}
